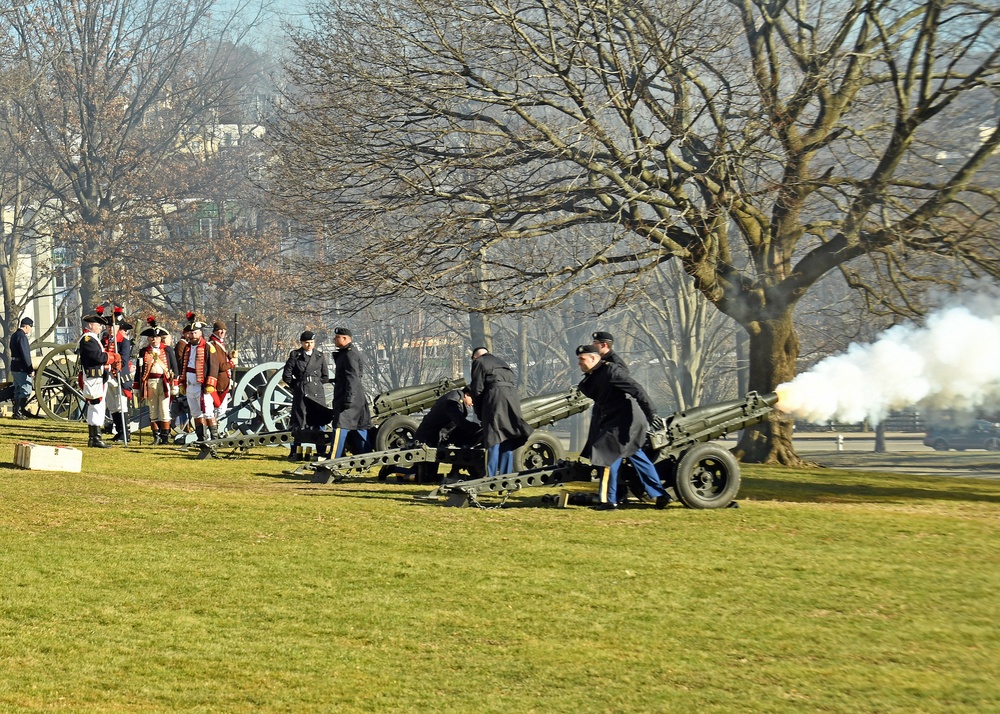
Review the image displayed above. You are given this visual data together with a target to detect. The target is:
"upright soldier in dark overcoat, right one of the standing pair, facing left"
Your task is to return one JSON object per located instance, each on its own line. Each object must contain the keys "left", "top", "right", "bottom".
{"left": 330, "top": 327, "right": 372, "bottom": 459}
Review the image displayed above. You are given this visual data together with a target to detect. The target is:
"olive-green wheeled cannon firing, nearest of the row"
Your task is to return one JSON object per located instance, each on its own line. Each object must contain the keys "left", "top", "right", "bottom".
{"left": 418, "top": 392, "right": 778, "bottom": 508}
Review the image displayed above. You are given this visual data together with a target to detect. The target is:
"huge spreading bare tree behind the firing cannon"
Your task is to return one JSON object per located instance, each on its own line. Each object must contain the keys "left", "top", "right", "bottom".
{"left": 272, "top": 0, "right": 1000, "bottom": 463}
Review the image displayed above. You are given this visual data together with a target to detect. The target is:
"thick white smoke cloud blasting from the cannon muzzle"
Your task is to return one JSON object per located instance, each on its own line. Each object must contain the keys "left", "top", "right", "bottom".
{"left": 776, "top": 289, "right": 1000, "bottom": 424}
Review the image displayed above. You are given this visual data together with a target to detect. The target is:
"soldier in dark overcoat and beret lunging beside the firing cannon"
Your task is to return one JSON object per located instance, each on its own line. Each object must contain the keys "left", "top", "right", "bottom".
{"left": 576, "top": 345, "right": 669, "bottom": 510}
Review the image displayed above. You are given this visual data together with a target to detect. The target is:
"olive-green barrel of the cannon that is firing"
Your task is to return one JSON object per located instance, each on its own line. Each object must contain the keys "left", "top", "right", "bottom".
{"left": 649, "top": 392, "right": 778, "bottom": 458}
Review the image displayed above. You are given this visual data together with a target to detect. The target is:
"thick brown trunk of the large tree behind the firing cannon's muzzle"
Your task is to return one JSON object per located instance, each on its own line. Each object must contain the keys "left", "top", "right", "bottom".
{"left": 733, "top": 307, "right": 802, "bottom": 466}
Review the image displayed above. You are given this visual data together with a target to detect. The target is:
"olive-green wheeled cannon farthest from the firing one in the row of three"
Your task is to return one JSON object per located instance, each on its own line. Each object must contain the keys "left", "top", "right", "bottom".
{"left": 197, "top": 375, "right": 465, "bottom": 459}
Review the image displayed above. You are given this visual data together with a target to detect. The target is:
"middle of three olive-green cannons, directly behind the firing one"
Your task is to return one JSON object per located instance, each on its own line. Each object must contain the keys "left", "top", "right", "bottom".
{"left": 308, "top": 387, "right": 591, "bottom": 483}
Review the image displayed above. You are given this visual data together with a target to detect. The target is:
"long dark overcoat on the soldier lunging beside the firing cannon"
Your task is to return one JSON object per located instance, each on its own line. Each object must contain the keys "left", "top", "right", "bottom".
{"left": 579, "top": 361, "right": 655, "bottom": 466}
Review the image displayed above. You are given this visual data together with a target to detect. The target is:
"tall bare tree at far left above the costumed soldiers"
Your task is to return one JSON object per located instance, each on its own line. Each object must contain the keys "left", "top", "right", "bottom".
{"left": 2, "top": 0, "right": 266, "bottom": 314}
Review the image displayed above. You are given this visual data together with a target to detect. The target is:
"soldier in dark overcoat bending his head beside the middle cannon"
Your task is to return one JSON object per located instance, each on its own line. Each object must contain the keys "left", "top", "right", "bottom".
{"left": 469, "top": 347, "right": 534, "bottom": 476}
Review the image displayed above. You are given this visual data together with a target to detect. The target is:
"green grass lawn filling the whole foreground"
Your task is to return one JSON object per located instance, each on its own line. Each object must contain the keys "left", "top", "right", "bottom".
{"left": 0, "top": 420, "right": 1000, "bottom": 714}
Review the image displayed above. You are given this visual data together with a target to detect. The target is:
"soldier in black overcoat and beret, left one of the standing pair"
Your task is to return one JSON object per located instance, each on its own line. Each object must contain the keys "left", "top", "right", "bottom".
{"left": 281, "top": 330, "right": 333, "bottom": 460}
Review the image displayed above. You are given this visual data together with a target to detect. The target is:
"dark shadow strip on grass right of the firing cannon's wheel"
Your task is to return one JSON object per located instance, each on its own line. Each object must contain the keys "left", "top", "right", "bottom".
{"left": 740, "top": 477, "right": 1000, "bottom": 503}
